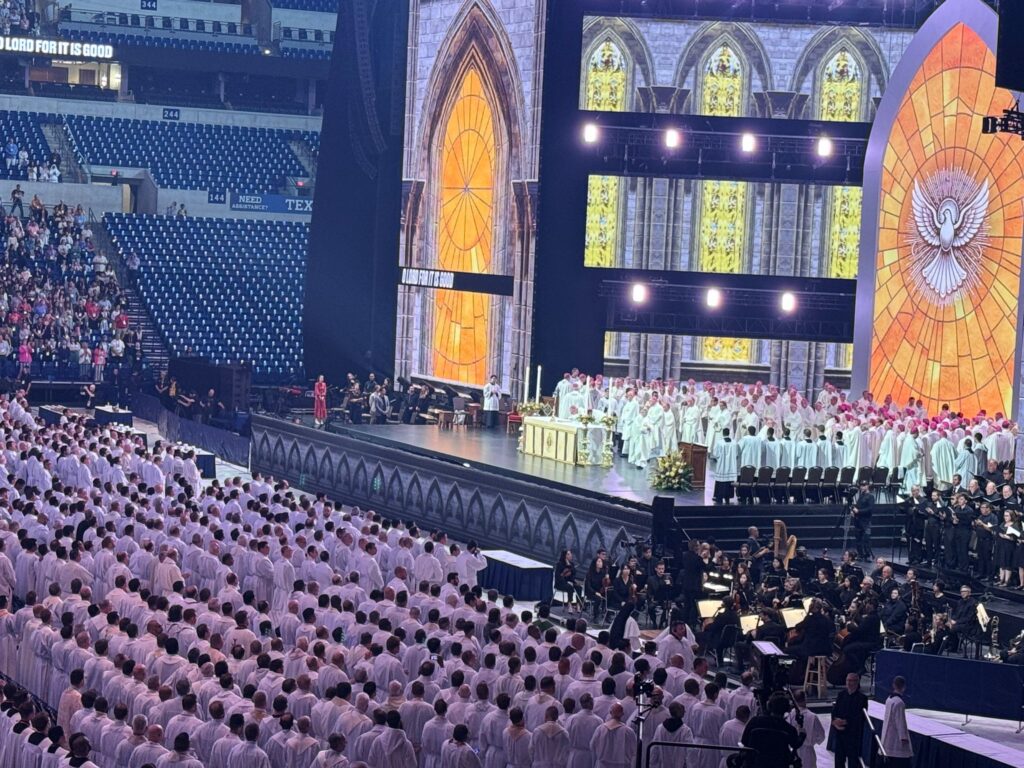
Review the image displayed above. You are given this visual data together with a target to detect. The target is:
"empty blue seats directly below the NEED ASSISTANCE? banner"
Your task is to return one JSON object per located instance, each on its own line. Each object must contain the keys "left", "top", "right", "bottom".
{"left": 104, "top": 214, "right": 309, "bottom": 382}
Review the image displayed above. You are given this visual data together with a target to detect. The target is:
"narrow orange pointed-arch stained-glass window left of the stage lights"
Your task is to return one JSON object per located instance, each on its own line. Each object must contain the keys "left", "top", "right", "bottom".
{"left": 433, "top": 68, "right": 497, "bottom": 383}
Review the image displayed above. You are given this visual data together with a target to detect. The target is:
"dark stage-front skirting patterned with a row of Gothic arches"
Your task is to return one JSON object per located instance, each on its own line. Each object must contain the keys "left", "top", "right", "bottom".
{"left": 251, "top": 415, "right": 650, "bottom": 563}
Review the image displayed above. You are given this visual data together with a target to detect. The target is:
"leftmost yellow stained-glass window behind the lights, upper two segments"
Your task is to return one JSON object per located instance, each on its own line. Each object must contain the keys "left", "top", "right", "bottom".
{"left": 584, "top": 40, "right": 629, "bottom": 267}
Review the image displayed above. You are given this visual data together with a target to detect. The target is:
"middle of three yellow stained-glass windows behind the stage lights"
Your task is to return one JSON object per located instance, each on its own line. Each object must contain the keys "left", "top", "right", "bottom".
{"left": 696, "top": 45, "right": 753, "bottom": 362}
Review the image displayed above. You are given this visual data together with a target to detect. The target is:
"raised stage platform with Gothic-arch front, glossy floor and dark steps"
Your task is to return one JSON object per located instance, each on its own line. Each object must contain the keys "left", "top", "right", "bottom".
{"left": 251, "top": 416, "right": 902, "bottom": 562}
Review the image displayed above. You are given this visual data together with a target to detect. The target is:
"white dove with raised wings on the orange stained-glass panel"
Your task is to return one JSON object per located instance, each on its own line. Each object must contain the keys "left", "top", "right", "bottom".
{"left": 910, "top": 169, "right": 988, "bottom": 304}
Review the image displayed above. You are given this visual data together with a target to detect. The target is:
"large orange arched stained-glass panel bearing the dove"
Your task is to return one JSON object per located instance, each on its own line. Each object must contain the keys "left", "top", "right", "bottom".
{"left": 869, "top": 24, "right": 1024, "bottom": 421}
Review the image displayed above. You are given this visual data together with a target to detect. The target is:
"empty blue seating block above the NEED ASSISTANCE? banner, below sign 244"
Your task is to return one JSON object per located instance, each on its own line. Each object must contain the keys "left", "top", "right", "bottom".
{"left": 67, "top": 115, "right": 307, "bottom": 193}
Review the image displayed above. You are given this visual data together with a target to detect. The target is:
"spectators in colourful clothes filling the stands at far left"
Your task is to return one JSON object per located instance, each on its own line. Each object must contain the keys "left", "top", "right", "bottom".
{"left": 0, "top": 187, "right": 141, "bottom": 382}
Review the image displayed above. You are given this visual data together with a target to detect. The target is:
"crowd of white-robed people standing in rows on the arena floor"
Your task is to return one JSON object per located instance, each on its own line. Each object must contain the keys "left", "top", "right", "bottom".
{"left": 0, "top": 405, "right": 782, "bottom": 768}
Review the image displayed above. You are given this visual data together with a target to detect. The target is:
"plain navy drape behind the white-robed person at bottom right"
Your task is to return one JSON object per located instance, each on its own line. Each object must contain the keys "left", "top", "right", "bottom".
{"left": 874, "top": 650, "right": 1024, "bottom": 721}
